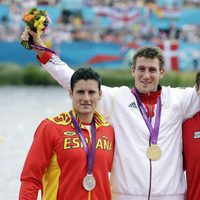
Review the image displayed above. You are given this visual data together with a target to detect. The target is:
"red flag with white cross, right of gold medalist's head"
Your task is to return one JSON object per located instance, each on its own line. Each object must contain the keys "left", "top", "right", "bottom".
{"left": 158, "top": 40, "right": 179, "bottom": 71}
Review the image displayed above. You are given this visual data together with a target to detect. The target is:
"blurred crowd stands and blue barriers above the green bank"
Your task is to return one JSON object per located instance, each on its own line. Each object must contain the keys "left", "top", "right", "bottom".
{"left": 0, "top": 0, "right": 200, "bottom": 71}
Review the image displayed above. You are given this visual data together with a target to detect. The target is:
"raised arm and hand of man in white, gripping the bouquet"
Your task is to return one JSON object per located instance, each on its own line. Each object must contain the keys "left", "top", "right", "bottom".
{"left": 22, "top": 28, "right": 118, "bottom": 115}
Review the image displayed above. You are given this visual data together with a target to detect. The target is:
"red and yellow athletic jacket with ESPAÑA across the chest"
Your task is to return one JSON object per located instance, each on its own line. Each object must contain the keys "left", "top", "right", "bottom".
{"left": 19, "top": 110, "right": 114, "bottom": 200}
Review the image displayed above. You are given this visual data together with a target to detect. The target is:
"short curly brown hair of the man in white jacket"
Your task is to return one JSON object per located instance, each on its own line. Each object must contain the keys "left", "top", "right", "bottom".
{"left": 132, "top": 46, "right": 164, "bottom": 69}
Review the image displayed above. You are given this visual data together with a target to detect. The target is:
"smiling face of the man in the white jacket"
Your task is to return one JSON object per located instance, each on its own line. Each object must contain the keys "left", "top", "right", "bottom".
{"left": 132, "top": 57, "right": 165, "bottom": 94}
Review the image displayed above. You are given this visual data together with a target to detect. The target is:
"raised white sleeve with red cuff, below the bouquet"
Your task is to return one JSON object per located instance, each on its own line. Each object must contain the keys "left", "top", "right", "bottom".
{"left": 39, "top": 54, "right": 74, "bottom": 91}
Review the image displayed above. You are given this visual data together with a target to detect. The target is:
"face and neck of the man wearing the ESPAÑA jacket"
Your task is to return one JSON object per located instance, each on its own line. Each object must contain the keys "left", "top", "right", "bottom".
{"left": 69, "top": 79, "right": 102, "bottom": 123}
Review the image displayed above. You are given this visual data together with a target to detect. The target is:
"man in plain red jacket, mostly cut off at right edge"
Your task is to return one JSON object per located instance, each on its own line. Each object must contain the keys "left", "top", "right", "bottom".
{"left": 183, "top": 72, "right": 200, "bottom": 200}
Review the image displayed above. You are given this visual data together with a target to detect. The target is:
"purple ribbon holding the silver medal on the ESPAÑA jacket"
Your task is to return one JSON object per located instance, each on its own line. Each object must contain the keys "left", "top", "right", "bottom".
{"left": 70, "top": 112, "right": 96, "bottom": 174}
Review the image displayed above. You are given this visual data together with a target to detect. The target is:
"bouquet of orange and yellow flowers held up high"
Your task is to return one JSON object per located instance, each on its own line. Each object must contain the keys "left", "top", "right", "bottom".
{"left": 21, "top": 8, "right": 50, "bottom": 50}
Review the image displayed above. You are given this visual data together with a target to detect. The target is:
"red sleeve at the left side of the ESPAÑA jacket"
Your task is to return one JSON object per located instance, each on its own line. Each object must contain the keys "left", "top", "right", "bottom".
{"left": 19, "top": 120, "right": 53, "bottom": 200}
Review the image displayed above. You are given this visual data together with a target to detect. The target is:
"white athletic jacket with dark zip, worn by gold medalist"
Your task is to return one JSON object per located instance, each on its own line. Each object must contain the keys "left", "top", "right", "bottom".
{"left": 43, "top": 55, "right": 200, "bottom": 200}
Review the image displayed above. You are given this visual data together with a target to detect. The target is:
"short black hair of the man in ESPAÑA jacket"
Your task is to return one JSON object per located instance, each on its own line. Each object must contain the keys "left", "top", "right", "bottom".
{"left": 70, "top": 67, "right": 101, "bottom": 91}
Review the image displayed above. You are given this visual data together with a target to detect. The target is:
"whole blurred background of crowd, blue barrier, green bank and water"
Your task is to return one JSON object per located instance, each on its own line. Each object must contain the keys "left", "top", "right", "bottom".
{"left": 0, "top": 0, "right": 200, "bottom": 200}
